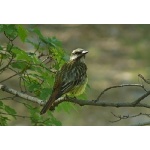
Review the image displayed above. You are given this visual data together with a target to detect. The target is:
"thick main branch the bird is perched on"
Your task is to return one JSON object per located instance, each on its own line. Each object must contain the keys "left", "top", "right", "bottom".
{"left": 0, "top": 84, "right": 150, "bottom": 110}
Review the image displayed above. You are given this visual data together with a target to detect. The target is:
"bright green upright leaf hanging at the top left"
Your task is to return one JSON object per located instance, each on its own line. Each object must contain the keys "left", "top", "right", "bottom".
{"left": 17, "top": 25, "right": 28, "bottom": 42}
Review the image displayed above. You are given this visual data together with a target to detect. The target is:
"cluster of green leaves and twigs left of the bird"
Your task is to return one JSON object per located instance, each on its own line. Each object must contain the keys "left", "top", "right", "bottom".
{"left": 0, "top": 25, "right": 74, "bottom": 125}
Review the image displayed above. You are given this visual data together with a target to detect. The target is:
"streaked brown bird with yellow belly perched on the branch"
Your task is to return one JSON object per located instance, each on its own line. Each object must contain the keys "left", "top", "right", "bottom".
{"left": 40, "top": 48, "right": 88, "bottom": 115}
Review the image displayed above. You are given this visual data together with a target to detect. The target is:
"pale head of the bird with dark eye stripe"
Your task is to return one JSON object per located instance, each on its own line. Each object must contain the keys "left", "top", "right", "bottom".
{"left": 70, "top": 48, "right": 88, "bottom": 61}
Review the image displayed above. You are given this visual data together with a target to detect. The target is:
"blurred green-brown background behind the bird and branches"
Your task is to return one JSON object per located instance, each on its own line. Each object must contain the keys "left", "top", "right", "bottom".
{"left": 0, "top": 24, "right": 150, "bottom": 126}
